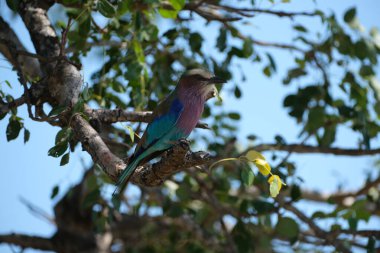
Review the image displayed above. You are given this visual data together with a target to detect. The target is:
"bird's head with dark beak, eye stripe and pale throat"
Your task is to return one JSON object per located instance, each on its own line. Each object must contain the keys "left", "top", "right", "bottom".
{"left": 179, "top": 69, "right": 226, "bottom": 100}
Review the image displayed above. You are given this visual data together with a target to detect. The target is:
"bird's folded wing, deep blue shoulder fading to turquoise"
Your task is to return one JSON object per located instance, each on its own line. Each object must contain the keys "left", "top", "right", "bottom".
{"left": 131, "top": 95, "right": 183, "bottom": 159}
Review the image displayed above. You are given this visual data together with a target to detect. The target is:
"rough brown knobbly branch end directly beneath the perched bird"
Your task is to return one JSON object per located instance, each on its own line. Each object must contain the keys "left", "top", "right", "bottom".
{"left": 131, "top": 140, "right": 212, "bottom": 186}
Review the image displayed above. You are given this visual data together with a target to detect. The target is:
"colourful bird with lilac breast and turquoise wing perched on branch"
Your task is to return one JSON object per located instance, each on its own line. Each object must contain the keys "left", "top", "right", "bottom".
{"left": 112, "top": 68, "right": 226, "bottom": 197}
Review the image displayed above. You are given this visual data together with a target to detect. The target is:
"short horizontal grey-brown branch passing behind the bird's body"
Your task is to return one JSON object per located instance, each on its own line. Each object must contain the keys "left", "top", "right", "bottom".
{"left": 85, "top": 108, "right": 209, "bottom": 129}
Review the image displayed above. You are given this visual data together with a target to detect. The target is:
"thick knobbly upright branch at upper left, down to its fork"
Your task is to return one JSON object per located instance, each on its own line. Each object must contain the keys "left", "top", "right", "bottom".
{"left": 19, "top": 0, "right": 82, "bottom": 106}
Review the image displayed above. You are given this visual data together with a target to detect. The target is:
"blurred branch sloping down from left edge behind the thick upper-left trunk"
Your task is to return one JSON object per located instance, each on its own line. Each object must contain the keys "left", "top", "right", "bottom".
{"left": 0, "top": 17, "right": 41, "bottom": 79}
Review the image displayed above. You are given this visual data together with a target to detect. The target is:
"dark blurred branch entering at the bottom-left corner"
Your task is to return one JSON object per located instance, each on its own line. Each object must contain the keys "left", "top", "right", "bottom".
{"left": 0, "top": 234, "right": 55, "bottom": 251}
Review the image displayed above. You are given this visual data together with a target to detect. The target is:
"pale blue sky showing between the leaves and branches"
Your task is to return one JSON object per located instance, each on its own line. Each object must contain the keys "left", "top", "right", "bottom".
{"left": 0, "top": 0, "right": 380, "bottom": 253}
